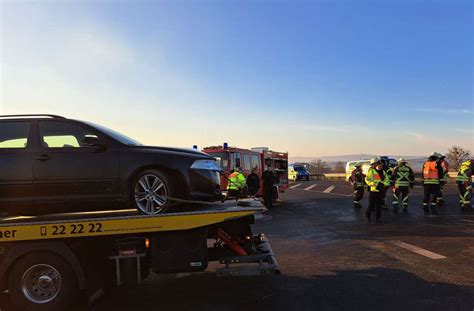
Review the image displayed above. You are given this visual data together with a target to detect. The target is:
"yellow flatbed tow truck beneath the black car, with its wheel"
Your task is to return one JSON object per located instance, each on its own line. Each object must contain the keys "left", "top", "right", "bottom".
{"left": 0, "top": 199, "right": 280, "bottom": 310}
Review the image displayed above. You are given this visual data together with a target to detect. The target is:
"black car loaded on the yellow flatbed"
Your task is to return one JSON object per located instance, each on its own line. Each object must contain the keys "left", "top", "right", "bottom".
{"left": 0, "top": 115, "right": 221, "bottom": 214}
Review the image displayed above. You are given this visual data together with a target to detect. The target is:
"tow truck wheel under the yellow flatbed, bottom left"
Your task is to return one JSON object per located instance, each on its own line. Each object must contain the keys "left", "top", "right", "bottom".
{"left": 8, "top": 251, "right": 79, "bottom": 311}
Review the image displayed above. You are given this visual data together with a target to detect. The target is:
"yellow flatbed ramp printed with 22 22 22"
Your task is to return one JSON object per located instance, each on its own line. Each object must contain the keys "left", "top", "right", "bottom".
{"left": 0, "top": 200, "right": 264, "bottom": 243}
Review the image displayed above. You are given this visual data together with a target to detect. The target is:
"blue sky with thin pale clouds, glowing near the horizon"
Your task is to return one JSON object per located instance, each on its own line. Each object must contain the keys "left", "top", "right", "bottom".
{"left": 0, "top": 0, "right": 474, "bottom": 156}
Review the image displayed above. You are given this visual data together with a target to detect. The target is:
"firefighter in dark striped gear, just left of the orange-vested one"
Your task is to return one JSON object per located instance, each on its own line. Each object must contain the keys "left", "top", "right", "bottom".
{"left": 391, "top": 158, "right": 415, "bottom": 213}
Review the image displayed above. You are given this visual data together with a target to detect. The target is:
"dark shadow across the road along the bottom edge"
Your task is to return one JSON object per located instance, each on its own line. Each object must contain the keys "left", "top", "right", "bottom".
{"left": 0, "top": 268, "right": 474, "bottom": 311}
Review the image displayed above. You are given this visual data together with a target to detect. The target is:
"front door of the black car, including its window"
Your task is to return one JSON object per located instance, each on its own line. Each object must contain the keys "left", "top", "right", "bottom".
{"left": 33, "top": 120, "right": 120, "bottom": 204}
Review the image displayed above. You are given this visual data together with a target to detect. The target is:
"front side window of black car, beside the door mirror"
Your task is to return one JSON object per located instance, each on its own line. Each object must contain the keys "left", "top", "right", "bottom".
{"left": 39, "top": 121, "right": 97, "bottom": 148}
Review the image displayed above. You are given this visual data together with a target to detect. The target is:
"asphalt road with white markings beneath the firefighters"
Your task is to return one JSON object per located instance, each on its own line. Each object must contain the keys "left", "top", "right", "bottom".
{"left": 0, "top": 181, "right": 474, "bottom": 311}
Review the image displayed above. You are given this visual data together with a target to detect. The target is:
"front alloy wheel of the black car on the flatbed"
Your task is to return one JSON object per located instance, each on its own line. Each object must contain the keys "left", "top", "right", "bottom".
{"left": 130, "top": 170, "right": 174, "bottom": 215}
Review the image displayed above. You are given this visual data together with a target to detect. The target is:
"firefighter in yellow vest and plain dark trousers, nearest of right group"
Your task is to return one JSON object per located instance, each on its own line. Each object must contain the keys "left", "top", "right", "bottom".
{"left": 365, "top": 158, "right": 390, "bottom": 223}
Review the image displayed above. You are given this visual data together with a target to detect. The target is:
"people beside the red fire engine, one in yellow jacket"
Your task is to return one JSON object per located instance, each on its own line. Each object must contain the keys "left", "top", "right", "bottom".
{"left": 224, "top": 166, "right": 278, "bottom": 208}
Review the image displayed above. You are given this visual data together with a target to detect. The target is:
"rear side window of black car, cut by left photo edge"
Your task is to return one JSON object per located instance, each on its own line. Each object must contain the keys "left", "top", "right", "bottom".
{"left": 0, "top": 122, "right": 30, "bottom": 149}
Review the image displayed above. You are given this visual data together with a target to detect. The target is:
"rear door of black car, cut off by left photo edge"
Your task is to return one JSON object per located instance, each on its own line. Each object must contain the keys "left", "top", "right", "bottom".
{"left": 0, "top": 120, "right": 33, "bottom": 209}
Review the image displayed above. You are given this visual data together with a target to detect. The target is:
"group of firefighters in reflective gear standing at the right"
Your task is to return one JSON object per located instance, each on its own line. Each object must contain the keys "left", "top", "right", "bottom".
{"left": 349, "top": 152, "right": 474, "bottom": 223}
